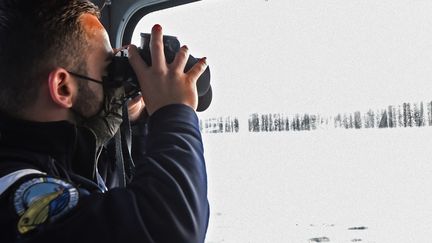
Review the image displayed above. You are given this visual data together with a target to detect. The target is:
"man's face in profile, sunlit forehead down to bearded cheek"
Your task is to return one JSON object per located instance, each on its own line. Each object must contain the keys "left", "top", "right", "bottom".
{"left": 73, "top": 14, "right": 113, "bottom": 117}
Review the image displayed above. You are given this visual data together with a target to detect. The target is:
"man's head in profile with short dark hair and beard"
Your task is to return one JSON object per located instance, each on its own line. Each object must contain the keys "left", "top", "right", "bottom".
{"left": 0, "top": 0, "right": 112, "bottom": 121}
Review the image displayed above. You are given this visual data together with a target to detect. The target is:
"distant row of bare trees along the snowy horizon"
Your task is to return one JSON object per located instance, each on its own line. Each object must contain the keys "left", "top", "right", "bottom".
{"left": 200, "top": 101, "right": 432, "bottom": 133}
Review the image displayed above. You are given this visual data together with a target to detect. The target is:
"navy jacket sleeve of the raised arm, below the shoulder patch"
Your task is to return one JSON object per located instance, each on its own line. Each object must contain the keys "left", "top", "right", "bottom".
{"left": 28, "top": 105, "right": 209, "bottom": 243}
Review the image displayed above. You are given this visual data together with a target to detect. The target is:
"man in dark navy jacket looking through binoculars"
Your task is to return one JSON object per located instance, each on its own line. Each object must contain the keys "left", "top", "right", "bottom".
{"left": 0, "top": 0, "right": 209, "bottom": 243}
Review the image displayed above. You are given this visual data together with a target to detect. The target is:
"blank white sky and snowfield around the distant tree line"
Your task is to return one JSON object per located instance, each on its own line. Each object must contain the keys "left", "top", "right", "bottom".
{"left": 133, "top": 0, "right": 432, "bottom": 243}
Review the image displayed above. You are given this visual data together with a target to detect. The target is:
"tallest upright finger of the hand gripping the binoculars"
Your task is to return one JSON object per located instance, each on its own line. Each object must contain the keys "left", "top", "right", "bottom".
{"left": 150, "top": 24, "right": 166, "bottom": 69}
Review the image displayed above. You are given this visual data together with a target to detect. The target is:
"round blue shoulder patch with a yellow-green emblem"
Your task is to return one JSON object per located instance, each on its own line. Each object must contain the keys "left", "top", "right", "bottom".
{"left": 14, "top": 177, "right": 79, "bottom": 234}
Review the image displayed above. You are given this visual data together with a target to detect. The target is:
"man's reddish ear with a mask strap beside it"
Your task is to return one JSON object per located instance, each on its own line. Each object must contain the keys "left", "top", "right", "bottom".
{"left": 48, "top": 68, "right": 76, "bottom": 108}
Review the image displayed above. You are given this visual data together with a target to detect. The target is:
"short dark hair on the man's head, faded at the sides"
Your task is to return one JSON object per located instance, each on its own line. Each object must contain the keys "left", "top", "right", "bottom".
{"left": 0, "top": 0, "right": 99, "bottom": 114}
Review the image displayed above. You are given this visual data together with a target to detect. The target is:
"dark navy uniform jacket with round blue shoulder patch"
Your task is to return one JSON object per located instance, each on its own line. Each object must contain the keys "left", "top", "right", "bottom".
{"left": 0, "top": 105, "right": 209, "bottom": 243}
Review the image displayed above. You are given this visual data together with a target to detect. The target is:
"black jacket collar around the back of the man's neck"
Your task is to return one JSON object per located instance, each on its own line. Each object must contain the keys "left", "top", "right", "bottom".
{"left": 0, "top": 114, "right": 96, "bottom": 179}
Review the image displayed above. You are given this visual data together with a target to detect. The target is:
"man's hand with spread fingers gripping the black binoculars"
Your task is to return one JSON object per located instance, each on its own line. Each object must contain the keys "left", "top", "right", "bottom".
{"left": 128, "top": 25, "right": 207, "bottom": 115}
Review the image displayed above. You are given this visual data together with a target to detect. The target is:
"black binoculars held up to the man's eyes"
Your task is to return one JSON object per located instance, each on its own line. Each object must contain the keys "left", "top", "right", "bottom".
{"left": 104, "top": 33, "right": 212, "bottom": 111}
